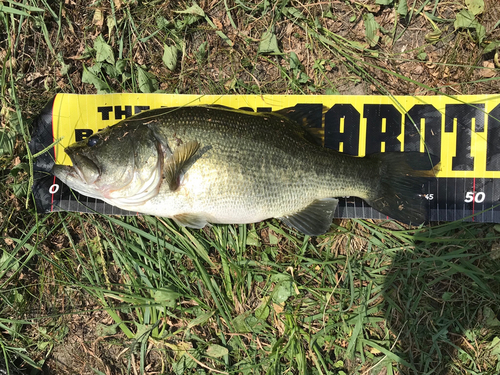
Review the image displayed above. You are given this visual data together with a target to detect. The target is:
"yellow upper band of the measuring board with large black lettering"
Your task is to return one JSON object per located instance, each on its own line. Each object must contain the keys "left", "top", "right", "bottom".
{"left": 52, "top": 94, "right": 500, "bottom": 178}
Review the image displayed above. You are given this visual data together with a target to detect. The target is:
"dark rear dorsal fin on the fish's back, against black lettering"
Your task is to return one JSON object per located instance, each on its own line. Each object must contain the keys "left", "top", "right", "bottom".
{"left": 275, "top": 104, "right": 327, "bottom": 146}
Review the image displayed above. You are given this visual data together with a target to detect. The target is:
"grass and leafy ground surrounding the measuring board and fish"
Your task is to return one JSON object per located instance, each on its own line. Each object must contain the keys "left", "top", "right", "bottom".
{"left": 0, "top": 0, "right": 500, "bottom": 375}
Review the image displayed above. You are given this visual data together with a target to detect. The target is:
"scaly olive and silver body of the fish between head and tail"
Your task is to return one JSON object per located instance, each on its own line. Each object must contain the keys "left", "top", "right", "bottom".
{"left": 144, "top": 107, "right": 374, "bottom": 223}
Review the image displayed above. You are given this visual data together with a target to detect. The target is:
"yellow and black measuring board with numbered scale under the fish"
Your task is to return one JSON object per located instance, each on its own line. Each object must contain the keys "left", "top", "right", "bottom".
{"left": 30, "top": 94, "right": 500, "bottom": 222}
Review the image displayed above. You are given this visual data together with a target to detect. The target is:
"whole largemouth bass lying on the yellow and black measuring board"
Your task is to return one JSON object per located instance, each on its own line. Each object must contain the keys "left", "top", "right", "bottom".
{"left": 53, "top": 106, "right": 434, "bottom": 235}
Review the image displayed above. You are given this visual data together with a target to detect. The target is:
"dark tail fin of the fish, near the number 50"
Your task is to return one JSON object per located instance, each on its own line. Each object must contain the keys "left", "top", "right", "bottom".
{"left": 366, "top": 152, "right": 439, "bottom": 224}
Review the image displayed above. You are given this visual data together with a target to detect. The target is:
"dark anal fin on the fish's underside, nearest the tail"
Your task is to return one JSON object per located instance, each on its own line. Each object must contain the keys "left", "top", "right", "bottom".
{"left": 279, "top": 198, "right": 339, "bottom": 236}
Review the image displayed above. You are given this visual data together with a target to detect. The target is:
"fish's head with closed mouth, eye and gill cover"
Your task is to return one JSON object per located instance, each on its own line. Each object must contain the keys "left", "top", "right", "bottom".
{"left": 52, "top": 122, "right": 163, "bottom": 209}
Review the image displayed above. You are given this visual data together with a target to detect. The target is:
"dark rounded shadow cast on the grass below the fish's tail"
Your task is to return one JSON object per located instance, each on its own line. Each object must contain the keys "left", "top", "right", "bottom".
{"left": 383, "top": 223, "right": 500, "bottom": 375}
